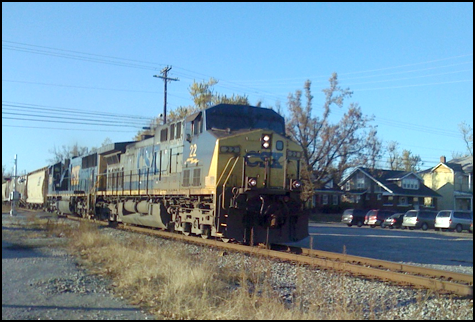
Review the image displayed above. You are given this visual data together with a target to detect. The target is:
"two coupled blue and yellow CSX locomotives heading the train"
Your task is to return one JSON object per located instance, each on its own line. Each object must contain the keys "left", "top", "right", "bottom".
{"left": 11, "top": 104, "right": 308, "bottom": 244}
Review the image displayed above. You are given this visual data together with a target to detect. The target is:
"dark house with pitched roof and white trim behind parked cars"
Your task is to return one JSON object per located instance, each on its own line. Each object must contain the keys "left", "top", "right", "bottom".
{"left": 338, "top": 167, "right": 440, "bottom": 212}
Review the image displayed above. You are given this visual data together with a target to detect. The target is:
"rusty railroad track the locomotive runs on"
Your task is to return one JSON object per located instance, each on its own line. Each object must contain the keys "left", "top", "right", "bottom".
{"left": 68, "top": 216, "right": 473, "bottom": 298}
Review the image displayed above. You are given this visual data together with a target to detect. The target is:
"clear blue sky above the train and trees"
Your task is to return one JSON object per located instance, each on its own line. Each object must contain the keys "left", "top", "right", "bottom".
{"left": 2, "top": 2, "right": 473, "bottom": 173}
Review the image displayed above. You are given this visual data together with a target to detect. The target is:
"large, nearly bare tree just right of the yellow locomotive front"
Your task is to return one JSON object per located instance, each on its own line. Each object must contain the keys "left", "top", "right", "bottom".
{"left": 286, "top": 73, "right": 382, "bottom": 199}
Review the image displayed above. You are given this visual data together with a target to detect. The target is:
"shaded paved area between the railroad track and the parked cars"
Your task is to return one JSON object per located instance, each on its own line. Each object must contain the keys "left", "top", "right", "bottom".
{"left": 292, "top": 223, "right": 473, "bottom": 267}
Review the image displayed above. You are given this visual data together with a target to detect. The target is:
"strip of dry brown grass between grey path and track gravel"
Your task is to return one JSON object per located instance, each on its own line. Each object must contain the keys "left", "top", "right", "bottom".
{"left": 31, "top": 216, "right": 452, "bottom": 320}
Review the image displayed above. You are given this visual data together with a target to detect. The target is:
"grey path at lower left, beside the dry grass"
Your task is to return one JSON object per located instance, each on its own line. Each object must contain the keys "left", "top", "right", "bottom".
{"left": 2, "top": 212, "right": 155, "bottom": 320}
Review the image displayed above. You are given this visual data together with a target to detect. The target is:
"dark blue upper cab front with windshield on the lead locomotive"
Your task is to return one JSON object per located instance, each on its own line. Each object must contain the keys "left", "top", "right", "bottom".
{"left": 206, "top": 104, "right": 285, "bottom": 135}
